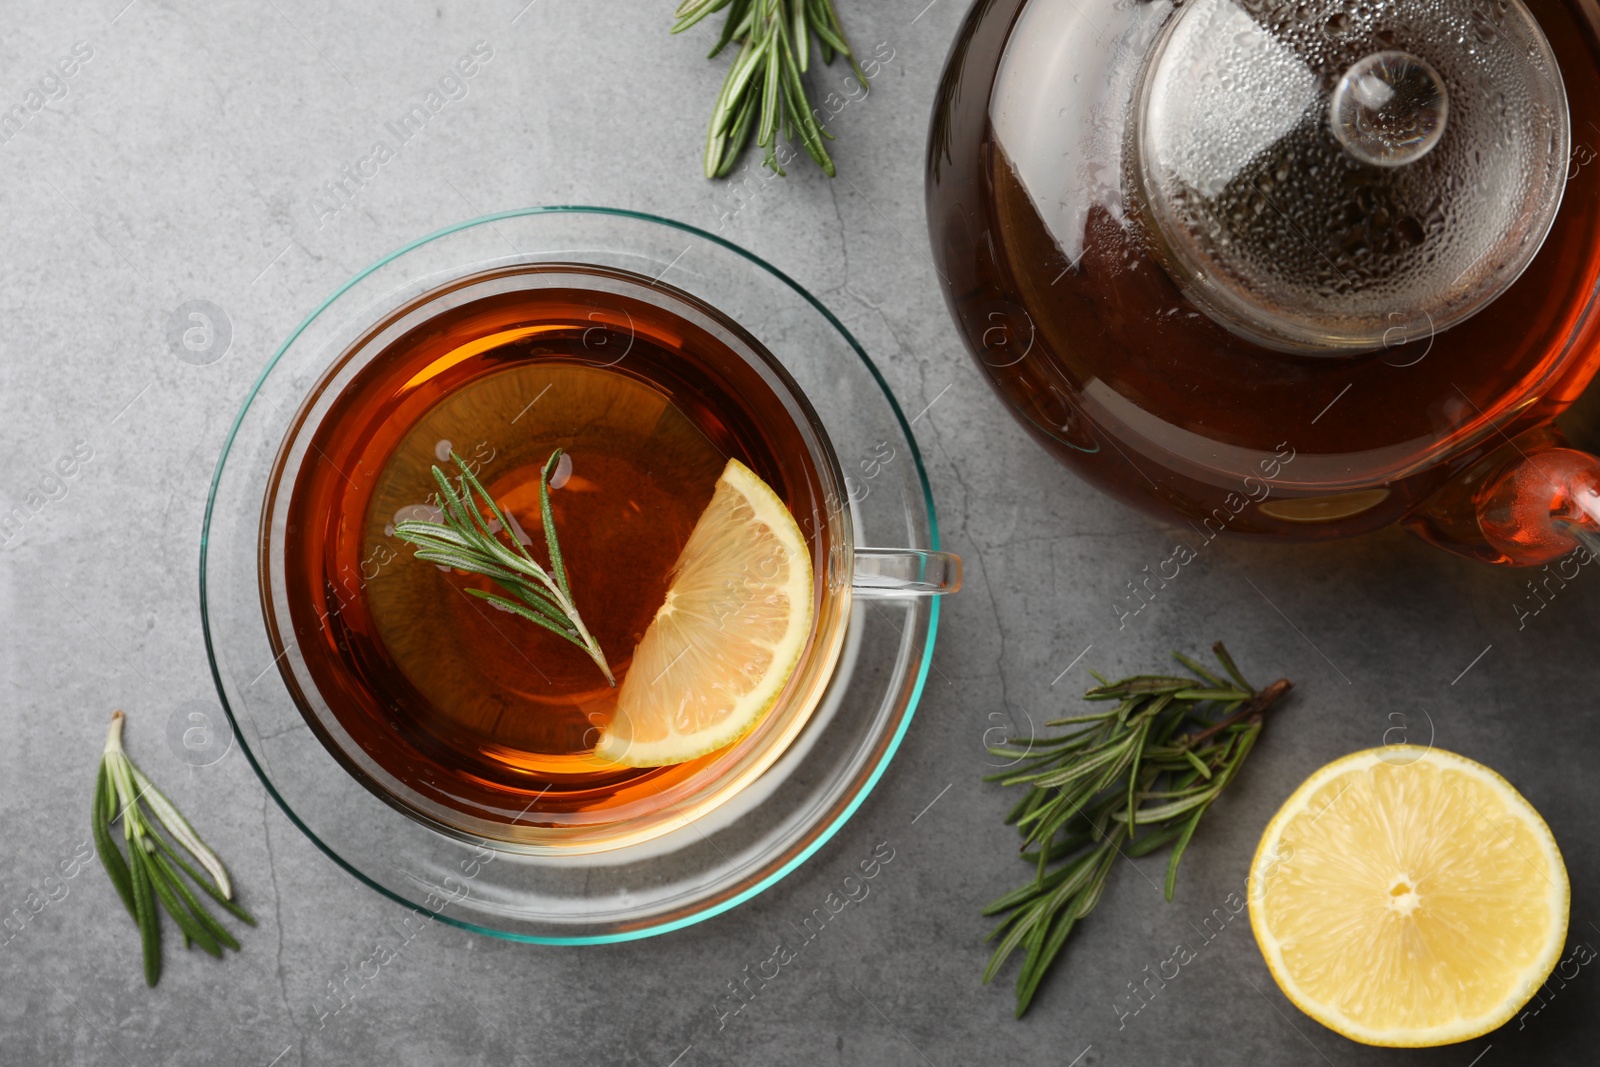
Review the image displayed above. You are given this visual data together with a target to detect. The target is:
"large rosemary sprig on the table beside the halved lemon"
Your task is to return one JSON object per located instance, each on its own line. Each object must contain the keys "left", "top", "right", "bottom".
{"left": 984, "top": 641, "right": 1293, "bottom": 1017}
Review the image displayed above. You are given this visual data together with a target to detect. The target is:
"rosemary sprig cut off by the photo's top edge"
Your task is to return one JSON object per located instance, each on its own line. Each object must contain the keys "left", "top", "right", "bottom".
{"left": 672, "top": 0, "right": 867, "bottom": 178}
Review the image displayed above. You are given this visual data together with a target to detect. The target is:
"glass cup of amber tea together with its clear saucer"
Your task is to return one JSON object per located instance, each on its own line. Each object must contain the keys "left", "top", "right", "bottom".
{"left": 202, "top": 210, "right": 960, "bottom": 941}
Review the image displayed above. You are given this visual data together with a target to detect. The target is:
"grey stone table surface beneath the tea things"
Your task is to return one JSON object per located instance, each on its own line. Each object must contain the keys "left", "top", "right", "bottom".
{"left": 0, "top": 0, "right": 1600, "bottom": 1067}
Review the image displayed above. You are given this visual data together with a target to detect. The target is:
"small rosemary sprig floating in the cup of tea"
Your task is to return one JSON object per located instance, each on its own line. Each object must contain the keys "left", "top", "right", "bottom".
{"left": 395, "top": 448, "right": 616, "bottom": 686}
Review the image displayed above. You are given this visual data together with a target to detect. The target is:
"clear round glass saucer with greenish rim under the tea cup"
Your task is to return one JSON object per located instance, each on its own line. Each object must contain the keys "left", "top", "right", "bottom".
{"left": 200, "top": 206, "right": 939, "bottom": 944}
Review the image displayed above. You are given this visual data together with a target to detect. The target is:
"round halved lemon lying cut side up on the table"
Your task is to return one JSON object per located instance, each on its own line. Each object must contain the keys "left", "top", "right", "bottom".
{"left": 1250, "top": 745, "right": 1571, "bottom": 1048}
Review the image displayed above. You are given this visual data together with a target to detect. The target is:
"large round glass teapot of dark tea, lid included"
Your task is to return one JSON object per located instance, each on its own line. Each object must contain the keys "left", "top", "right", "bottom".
{"left": 928, "top": 0, "right": 1600, "bottom": 565}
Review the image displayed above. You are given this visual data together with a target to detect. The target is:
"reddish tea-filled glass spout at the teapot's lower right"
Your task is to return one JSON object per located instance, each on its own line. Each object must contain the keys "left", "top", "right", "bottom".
{"left": 1406, "top": 427, "right": 1600, "bottom": 566}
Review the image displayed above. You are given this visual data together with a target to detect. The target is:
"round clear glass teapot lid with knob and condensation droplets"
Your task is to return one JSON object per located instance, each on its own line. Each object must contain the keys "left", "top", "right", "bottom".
{"left": 1128, "top": 0, "right": 1570, "bottom": 354}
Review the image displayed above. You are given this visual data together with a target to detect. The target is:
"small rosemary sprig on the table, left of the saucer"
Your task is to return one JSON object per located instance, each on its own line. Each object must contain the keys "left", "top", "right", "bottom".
{"left": 90, "top": 710, "right": 256, "bottom": 985}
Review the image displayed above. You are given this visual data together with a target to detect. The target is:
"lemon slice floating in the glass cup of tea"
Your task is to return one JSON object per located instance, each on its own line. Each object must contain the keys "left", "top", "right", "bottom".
{"left": 595, "top": 459, "right": 814, "bottom": 766}
